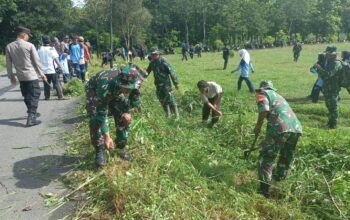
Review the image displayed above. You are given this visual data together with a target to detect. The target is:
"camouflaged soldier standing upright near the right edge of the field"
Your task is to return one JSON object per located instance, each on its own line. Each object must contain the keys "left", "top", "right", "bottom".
{"left": 314, "top": 45, "right": 342, "bottom": 129}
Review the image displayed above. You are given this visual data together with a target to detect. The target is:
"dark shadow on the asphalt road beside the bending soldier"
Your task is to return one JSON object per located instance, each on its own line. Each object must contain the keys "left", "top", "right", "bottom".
{"left": 13, "top": 155, "right": 78, "bottom": 189}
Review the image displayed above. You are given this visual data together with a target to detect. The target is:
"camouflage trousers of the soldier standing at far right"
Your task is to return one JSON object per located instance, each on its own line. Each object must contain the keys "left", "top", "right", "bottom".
{"left": 323, "top": 91, "right": 339, "bottom": 128}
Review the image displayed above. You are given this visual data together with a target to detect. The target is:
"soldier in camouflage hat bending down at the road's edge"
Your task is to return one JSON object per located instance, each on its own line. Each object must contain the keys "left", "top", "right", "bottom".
{"left": 86, "top": 65, "right": 144, "bottom": 166}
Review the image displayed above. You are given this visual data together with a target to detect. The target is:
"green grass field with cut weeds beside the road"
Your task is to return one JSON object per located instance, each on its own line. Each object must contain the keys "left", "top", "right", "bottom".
{"left": 63, "top": 44, "right": 350, "bottom": 219}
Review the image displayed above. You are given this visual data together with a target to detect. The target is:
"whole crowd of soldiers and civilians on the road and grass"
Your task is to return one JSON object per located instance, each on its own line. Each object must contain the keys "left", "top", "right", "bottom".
{"left": 6, "top": 24, "right": 350, "bottom": 197}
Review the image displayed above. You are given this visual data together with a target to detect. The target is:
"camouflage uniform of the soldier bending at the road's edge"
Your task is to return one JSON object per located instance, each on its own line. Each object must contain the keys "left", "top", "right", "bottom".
{"left": 85, "top": 67, "right": 138, "bottom": 165}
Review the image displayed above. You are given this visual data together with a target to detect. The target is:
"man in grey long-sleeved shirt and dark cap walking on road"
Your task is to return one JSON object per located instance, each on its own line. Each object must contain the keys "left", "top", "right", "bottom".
{"left": 6, "top": 26, "right": 47, "bottom": 127}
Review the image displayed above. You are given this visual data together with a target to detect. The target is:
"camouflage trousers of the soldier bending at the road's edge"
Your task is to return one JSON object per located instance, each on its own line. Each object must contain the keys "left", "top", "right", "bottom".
{"left": 86, "top": 89, "right": 129, "bottom": 149}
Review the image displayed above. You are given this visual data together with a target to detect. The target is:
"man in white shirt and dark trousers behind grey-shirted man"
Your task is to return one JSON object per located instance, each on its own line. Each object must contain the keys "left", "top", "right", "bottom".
{"left": 38, "top": 35, "right": 66, "bottom": 100}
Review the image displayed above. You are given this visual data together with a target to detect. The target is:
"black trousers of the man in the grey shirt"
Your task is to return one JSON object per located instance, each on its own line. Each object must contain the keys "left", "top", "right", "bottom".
{"left": 19, "top": 80, "right": 41, "bottom": 115}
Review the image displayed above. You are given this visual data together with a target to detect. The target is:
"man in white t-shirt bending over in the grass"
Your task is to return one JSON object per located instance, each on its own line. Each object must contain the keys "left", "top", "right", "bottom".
{"left": 197, "top": 80, "right": 222, "bottom": 127}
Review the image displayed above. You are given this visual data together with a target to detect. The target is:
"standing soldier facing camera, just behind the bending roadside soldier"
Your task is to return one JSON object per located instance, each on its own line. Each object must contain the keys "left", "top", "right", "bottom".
{"left": 147, "top": 47, "right": 180, "bottom": 119}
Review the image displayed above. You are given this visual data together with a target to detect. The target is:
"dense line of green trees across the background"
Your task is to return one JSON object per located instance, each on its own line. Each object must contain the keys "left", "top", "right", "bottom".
{"left": 0, "top": 0, "right": 350, "bottom": 52}
